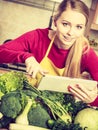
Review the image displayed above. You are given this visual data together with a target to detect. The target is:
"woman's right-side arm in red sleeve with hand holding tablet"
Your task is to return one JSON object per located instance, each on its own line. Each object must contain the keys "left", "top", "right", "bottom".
{"left": 69, "top": 48, "right": 98, "bottom": 106}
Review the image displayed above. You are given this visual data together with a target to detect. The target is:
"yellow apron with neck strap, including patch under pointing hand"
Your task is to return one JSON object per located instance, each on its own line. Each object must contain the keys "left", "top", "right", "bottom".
{"left": 29, "top": 35, "right": 65, "bottom": 87}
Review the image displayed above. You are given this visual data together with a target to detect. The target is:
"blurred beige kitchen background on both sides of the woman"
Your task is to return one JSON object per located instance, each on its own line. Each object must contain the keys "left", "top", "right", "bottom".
{"left": 0, "top": 0, "right": 98, "bottom": 51}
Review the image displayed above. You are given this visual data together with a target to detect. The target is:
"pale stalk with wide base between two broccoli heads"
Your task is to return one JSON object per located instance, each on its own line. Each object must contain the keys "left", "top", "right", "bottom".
{"left": 15, "top": 99, "right": 32, "bottom": 125}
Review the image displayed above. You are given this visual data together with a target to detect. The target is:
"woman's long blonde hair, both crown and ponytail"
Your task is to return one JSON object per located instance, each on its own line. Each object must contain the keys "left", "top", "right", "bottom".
{"left": 54, "top": 0, "right": 89, "bottom": 78}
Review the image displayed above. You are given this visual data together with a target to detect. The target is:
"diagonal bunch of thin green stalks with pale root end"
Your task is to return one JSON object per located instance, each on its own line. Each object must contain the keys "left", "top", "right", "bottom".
{"left": 23, "top": 82, "right": 71, "bottom": 123}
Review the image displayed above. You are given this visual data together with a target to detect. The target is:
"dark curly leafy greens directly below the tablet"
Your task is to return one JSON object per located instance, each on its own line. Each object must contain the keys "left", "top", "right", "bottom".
{"left": 41, "top": 90, "right": 88, "bottom": 121}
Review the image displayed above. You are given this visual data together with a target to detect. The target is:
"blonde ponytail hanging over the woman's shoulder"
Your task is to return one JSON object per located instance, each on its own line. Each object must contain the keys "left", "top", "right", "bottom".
{"left": 64, "top": 36, "right": 89, "bottom": 78}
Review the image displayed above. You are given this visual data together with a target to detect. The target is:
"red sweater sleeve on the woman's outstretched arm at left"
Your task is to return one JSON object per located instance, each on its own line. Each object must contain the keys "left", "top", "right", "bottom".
{"left": 0, "top": 31, "right": 36, "bottom": 63}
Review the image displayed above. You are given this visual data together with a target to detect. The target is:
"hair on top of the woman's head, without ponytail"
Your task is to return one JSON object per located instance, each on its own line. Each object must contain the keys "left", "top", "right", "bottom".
{"left": 53, "top": 0, "right": 89, "bottom": 23}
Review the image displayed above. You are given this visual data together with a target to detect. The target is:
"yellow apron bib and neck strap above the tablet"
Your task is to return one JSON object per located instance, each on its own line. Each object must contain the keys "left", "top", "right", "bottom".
{"left": 40, "top": 35, "right": 65, "bottom": 76}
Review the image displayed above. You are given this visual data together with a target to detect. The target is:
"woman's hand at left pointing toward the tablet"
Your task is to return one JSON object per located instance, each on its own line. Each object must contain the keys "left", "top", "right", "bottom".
{"left": 25, "top": 56, "right": 48, "bottom": 78}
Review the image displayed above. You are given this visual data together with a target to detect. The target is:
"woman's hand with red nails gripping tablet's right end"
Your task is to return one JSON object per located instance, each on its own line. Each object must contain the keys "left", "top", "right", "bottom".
{"left": 68, "top": 84, "right": 98, "bottom": 103}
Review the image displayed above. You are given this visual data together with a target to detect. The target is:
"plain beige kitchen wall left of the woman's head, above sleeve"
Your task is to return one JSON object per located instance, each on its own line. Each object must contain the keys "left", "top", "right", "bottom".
{"left": 0, "top": 0, "right": 51, "bottom": 44}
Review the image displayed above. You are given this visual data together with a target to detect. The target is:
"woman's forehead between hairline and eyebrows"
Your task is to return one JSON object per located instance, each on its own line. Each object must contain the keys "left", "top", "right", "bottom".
{"left": 60, "top": 9, "right": 86, "bottom": 25}
